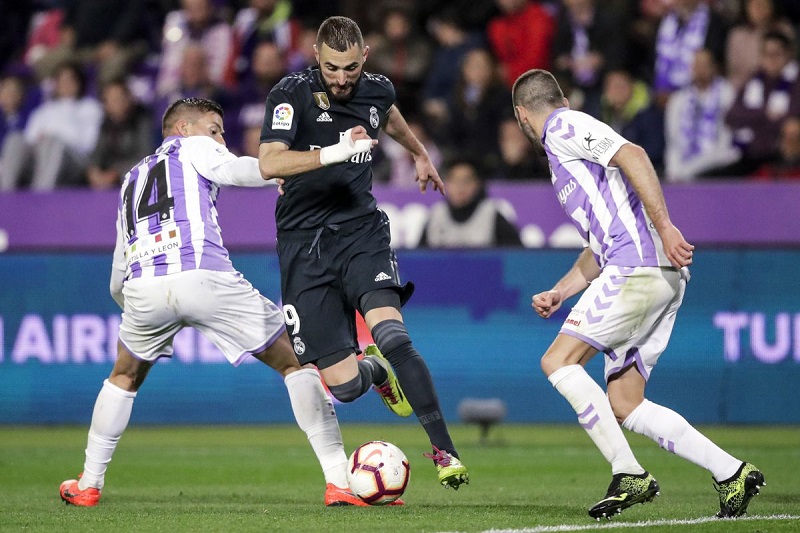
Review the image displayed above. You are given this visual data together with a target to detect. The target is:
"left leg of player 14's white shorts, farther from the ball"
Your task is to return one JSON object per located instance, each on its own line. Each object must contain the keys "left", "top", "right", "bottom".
{"left": 119, "top": 275, "right": 183, "bottom": 362}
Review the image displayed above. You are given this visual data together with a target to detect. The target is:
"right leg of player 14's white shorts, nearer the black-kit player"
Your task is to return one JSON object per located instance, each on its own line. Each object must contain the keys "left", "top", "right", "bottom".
{"left": 183, "top": 270, "right": 285, "bottom": 365}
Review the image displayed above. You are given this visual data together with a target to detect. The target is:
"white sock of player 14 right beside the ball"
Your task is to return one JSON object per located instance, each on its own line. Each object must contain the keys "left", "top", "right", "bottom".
{"left": 284, "top": 368, "right": 348, "bottom": 488}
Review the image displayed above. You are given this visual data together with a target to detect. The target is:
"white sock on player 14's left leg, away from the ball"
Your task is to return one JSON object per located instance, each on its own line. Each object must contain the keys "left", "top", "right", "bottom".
{"left": 78, "top": 379, "right": 136, "bottom": 490}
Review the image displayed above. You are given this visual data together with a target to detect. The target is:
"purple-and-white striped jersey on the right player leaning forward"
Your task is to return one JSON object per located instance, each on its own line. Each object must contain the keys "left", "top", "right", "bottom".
{"left": 542, "top": 107, "right": 671, "bottom": 268}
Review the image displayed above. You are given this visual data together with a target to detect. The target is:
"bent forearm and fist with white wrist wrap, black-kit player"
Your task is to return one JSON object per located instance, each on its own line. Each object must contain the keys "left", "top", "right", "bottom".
{"left": 258, "top": 126, "right": 378, "bottom": 184}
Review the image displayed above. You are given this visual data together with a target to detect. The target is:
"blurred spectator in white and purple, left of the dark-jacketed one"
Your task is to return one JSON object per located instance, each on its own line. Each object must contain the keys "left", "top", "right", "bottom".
{"left": 665, "top": 49, "right": 741, "bottom": 181}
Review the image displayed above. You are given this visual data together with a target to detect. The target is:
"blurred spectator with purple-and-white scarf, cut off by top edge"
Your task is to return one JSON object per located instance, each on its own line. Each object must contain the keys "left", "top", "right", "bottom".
{"left": 653, "top": 0, "right": 727, "bottom": 109}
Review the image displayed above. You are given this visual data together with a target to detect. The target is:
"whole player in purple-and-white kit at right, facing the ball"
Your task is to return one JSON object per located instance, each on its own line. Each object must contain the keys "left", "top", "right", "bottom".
{"left": 513, "top": 70, "right": 764, "bottom": 520}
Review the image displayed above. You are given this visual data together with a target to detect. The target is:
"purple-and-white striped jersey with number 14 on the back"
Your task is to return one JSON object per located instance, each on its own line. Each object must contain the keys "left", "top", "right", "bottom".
{"left": 115, "top": 136, "right": 237, "bottom": 279}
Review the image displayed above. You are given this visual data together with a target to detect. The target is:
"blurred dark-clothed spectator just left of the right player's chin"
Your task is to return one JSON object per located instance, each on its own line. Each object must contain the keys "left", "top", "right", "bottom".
{"left": 493, "top": 118, "right": 550, "bottom": 181}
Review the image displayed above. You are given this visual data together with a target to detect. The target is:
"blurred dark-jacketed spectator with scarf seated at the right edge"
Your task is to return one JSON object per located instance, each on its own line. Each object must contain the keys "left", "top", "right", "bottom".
{"left": 712, "top": 32, "right": 800, "bottom": 176}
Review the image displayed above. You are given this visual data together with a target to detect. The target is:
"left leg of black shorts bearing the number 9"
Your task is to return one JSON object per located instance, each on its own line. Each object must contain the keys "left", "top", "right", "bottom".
{"left": 278, "top": 235, "right": 358, "bottom": 364}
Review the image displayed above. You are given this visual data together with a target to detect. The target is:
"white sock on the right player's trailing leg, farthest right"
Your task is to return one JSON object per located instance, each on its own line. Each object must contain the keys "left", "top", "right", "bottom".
{"left": 622, "top": 400, "right": 742, "bottom": 481}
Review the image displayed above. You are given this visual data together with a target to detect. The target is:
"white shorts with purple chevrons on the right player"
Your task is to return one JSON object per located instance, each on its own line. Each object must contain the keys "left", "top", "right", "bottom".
{"left": 560, "top": 266, "right": 689, "bottom": 382}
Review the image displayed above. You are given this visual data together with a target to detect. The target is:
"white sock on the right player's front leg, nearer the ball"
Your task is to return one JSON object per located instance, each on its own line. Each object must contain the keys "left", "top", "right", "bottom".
{"left": 547, "top": 365, "right": 644, "bottom": 474}
